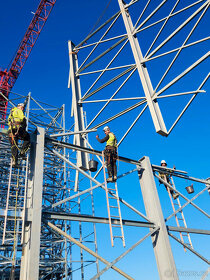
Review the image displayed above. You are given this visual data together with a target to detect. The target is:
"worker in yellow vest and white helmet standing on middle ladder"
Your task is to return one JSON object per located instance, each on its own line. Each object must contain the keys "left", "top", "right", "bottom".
{"left": 96, "top": 126, "right": 117, "bottom": 182}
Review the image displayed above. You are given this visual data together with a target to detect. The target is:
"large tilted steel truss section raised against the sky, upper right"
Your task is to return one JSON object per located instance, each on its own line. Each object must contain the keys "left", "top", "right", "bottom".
{"left": 69, "top": 0, "right": 210, "bottom": 139}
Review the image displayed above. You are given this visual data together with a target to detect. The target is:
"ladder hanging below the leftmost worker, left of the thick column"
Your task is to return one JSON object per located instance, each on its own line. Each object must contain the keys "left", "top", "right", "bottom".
{"left": 2, "top": 157, "right": 28, "bottom": 247}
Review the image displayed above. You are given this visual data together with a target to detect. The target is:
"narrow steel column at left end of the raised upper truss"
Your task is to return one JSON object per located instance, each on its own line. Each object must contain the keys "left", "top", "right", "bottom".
{"left": 68, "top": 41, "right": 88, "bottom": 170}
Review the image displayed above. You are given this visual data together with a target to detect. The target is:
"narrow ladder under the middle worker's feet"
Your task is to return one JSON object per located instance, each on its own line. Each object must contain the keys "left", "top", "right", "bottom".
{"left": 102, "top": 152, "right": 125, "bottom": 247}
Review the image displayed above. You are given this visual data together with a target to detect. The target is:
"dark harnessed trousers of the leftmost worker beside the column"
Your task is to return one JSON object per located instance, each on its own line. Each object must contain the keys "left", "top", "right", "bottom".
{"left": 9, "top": 126, "right": 30, "bottom": 162}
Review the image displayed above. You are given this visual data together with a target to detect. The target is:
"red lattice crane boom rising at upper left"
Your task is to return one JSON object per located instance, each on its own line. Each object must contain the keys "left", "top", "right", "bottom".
{"left": 0, "top": 0, "right": 56, "bottom": 121}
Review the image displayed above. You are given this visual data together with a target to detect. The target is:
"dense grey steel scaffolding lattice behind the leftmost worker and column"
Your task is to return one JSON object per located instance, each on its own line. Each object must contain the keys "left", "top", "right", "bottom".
{"left": 0, "top": 93, "right": 98, "bottom": 279}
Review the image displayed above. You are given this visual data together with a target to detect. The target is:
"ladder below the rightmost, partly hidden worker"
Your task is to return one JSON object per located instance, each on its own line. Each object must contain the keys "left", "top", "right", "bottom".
{"left": 165, "top": 176, "right": 193, "bottom": 252}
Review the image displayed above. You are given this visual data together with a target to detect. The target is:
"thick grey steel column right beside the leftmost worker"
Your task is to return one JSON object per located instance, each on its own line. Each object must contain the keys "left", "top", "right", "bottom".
{"left": 20, "top": 128, "right": 45, "bottom": 280}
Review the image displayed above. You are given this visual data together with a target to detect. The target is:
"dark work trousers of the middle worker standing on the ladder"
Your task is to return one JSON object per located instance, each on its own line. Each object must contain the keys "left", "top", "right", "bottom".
{"left": 104, "top": 146, "right": 117, "bottom": 177}
